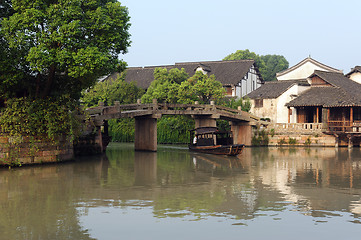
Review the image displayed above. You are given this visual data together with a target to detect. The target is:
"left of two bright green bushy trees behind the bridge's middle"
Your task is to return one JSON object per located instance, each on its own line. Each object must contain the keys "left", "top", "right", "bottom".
{"left": 142, "top": 68, "right": 189, "bottom": 103}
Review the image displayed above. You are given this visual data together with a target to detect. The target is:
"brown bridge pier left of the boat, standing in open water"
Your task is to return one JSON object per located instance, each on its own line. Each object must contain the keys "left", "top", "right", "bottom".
{"left": 134, "top": 117, "right": 157, "bottom": 152}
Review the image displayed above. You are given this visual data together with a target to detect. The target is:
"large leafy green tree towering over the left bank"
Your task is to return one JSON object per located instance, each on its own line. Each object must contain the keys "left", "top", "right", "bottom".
{"left": 0, "top": 0, "right": 130, "bottom": 98}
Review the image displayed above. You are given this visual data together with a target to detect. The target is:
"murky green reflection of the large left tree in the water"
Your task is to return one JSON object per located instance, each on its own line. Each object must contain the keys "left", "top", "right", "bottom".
{"left": 0, "top": 164, "right": 93, "bottom": 239}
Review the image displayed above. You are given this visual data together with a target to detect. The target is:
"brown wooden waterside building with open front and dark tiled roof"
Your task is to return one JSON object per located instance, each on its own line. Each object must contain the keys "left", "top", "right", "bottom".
{"left": 286, "top": 70, "right": 361, "bottom": 133}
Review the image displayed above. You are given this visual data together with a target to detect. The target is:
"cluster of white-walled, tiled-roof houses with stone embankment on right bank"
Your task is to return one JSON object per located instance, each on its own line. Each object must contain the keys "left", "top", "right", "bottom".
{"left": 248, "top": 58, "right": 361, "bottom": 147}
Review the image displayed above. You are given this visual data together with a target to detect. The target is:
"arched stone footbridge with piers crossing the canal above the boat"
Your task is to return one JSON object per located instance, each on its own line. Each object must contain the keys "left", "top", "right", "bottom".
{"left": 87, "top": 101, "right": 260, "bottom": 151}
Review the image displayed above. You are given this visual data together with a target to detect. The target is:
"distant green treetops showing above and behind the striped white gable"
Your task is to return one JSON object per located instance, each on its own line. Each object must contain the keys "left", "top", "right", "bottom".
{"left": 223, "top": 49, "right": 289, "bottom": 81}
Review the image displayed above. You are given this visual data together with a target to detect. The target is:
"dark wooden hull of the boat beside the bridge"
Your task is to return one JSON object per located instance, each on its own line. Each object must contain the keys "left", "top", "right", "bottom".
{"left": 189, "top": 144, "right": 244, "bottom": 156}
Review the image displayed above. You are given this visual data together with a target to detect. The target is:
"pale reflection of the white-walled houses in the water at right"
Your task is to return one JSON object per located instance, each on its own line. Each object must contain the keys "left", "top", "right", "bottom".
{"left": 252, "top": 148, "right": 361, "bottom": 216}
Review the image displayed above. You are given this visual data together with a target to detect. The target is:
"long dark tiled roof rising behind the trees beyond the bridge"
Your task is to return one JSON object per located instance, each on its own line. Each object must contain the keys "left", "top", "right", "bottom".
{"left": 105, "top": 60, "right": 262, "bottom": 89}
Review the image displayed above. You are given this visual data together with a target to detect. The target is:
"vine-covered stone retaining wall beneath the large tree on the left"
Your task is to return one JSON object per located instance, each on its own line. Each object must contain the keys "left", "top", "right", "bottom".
{"left": 0, "top": 136, "right": 74, "bottom": 166}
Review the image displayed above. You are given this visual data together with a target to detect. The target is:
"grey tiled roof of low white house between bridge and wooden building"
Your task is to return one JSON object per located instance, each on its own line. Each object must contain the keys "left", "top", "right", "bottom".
{"left": 247, "top": 79, "right": 309, "bottom": 99}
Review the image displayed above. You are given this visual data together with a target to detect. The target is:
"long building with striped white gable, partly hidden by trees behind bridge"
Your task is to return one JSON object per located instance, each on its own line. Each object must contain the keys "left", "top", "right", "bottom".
{"left": 104, "top": 60, "right": 263, "bottom": 98}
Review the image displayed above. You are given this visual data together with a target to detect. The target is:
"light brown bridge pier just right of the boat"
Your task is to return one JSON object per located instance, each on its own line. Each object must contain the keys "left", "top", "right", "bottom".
{"left": 231, "top": 121, "right": 252, "bottom": 146}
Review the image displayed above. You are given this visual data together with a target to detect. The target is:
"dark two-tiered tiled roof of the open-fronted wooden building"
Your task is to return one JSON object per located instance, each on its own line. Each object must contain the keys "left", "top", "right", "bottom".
{"left": 286, "top": 70, "right": 361, "bottom": 107}
